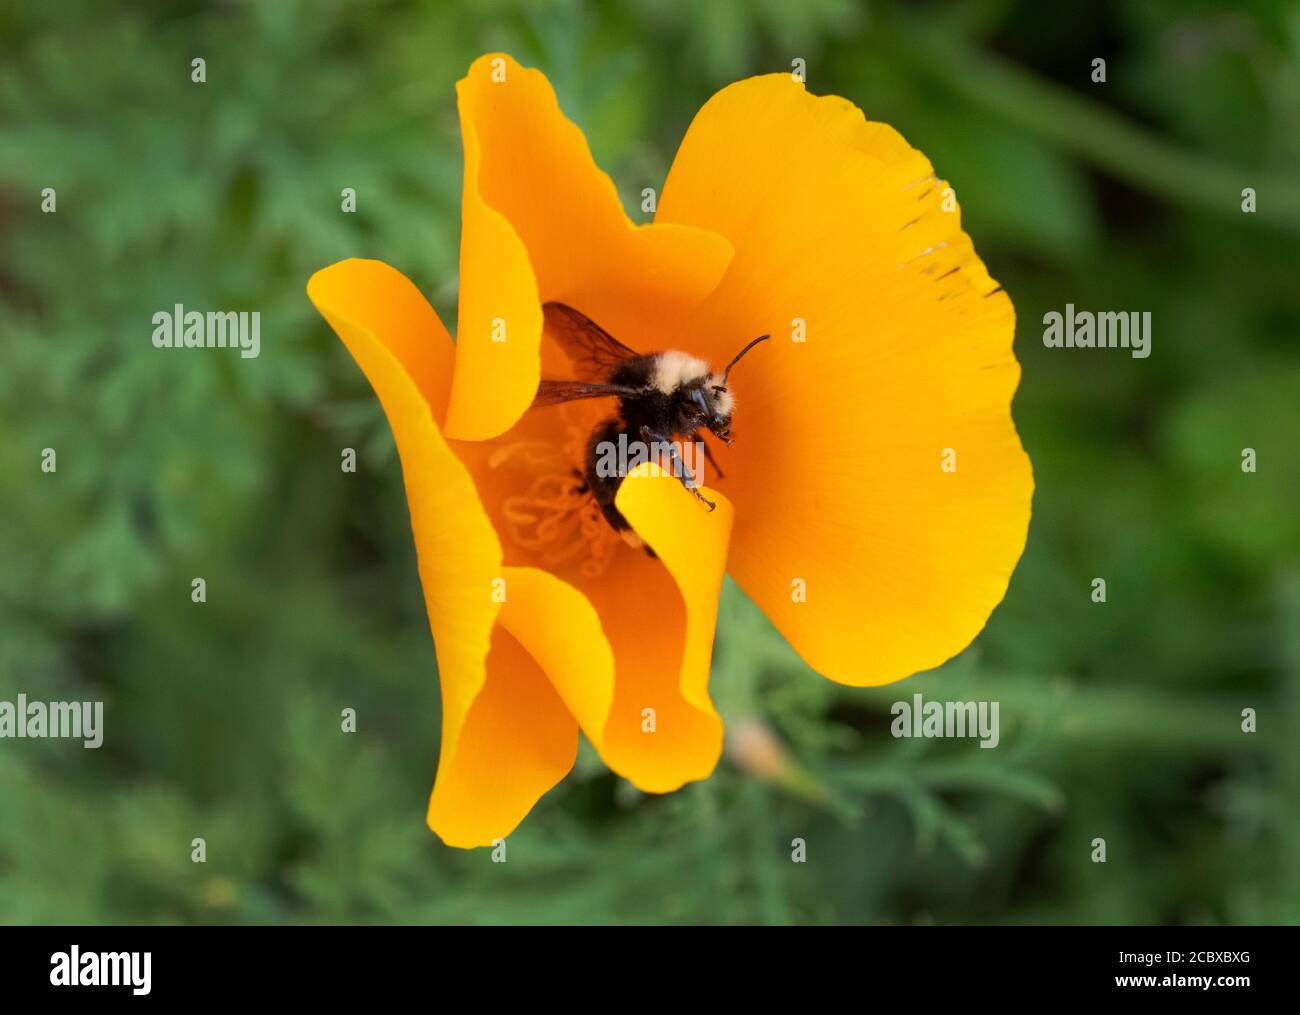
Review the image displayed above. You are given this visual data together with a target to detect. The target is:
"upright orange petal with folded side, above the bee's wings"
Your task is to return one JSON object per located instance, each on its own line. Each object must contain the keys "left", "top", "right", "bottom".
{"left": 446, "top": 53, "right": 732, "bottom": 441}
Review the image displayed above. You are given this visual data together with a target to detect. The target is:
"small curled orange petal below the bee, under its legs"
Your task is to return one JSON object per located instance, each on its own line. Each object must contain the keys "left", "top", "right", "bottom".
{"left": 488, "top": 465, "right": 732, "bottom": 793}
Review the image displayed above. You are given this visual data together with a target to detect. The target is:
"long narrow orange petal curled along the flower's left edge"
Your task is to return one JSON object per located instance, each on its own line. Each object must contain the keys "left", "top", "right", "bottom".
{"left": 307, "top": 260, "right": 577, "bottom": 846}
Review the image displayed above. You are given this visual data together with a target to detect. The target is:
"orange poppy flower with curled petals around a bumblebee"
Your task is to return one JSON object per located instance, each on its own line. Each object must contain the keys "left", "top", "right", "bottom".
{"left": 307, "top": 55, "right": 1032, "bottom": 846}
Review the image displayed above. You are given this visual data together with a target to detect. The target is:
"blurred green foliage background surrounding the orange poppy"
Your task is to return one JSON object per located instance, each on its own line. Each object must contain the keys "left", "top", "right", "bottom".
{"left": 0, "top": 0, "right": 1300, "bottom": 923}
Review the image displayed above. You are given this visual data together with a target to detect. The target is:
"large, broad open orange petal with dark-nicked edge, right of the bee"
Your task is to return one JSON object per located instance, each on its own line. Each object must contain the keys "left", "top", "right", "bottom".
{"left": 659, "top": 74, "right": 1034, "bottom": 684}
